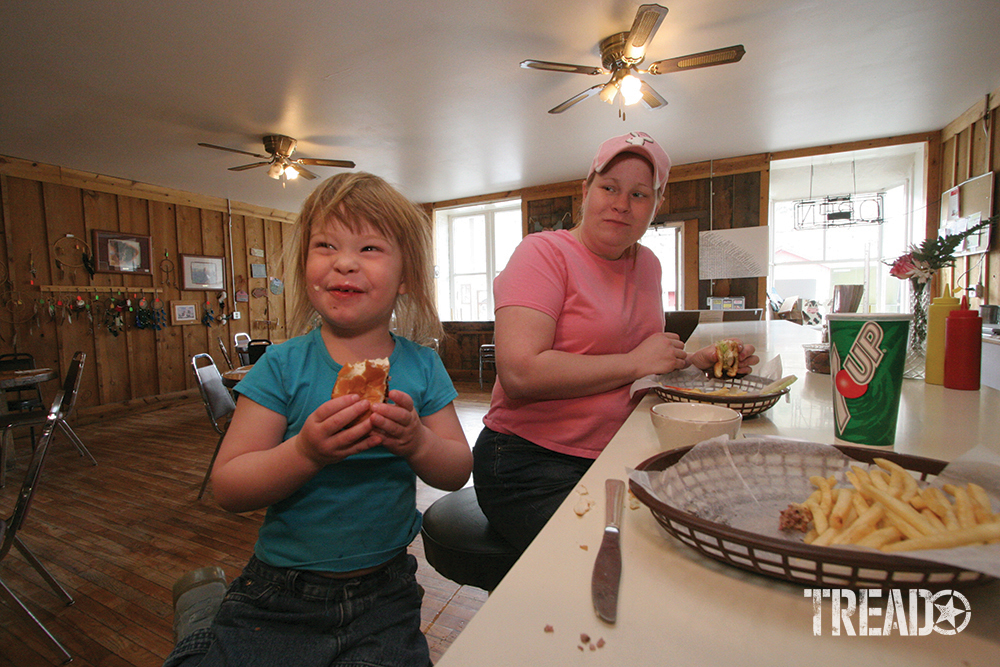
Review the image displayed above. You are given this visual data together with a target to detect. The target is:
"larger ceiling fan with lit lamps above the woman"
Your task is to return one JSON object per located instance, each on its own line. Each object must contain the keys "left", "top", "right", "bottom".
{"left": 521, "top": 5, "right": 746, "bottom": 118}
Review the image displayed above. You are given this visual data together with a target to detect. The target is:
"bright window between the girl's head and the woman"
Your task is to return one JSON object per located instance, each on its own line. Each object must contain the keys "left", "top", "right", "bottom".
{"left": 434, "top": 199, "right": 522, "bottom": 321}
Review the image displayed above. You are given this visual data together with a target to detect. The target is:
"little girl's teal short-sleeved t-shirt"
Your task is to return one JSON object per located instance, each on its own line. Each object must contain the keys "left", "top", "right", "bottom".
{"left": 235, "top": 329, "right": 458, "bottom": 572}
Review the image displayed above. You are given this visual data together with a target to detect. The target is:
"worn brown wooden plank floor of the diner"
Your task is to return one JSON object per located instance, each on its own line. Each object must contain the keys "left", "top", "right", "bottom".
{"left": 0, "top": 383, "right": 489, "bottom": 667}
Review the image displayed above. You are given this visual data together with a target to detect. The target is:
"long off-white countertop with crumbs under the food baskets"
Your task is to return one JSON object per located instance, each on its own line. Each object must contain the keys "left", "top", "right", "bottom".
{"left": 438, "top": 321, "right": 1000, "bottom": 667}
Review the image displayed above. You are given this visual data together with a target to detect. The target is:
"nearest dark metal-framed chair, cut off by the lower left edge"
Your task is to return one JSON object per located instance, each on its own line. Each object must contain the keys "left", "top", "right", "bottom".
{"left": 0, "top": 389, "right": 73, "bottom": 662}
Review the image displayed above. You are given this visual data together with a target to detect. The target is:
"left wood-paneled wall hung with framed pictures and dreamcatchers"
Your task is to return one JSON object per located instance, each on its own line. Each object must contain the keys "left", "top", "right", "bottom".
{"left": 0, "top": 158, "right": 292, "bottom": 419}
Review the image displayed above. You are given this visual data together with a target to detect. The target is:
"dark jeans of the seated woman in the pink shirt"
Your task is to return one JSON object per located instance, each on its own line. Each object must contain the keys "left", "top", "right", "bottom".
{"left": 472, "top": 428, "right": 594, "bottom": 551}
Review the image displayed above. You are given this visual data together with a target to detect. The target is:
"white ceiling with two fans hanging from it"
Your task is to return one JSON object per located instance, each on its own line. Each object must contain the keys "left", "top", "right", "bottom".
{"left": 0, "top": 0, "right": 1000, "bottom": 211}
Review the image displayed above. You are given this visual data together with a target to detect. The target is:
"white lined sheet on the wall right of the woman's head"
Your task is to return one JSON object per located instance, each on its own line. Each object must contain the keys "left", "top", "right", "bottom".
{"left": 698, "top": 227, "right": 770, "bottom": 280}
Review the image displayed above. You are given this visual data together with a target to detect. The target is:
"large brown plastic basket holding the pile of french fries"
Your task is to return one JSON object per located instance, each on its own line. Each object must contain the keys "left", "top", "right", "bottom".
{"left": 629, "top": 445, "right": 994, "bottom": 589}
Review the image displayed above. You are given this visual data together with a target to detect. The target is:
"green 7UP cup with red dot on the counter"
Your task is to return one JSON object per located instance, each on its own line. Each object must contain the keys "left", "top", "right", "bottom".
{"left": 827, "top": 313, "right": 912, "bottom": 447}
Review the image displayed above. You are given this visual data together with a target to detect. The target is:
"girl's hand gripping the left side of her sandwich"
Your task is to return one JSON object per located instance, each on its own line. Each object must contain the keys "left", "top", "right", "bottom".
{"left": 295, "top": 394, "right": 380, "bottom": 468}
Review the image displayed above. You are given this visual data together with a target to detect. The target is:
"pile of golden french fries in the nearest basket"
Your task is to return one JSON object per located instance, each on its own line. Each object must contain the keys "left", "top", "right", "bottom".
{"left": 785, "top": 458, "right": 1000, "bottom": 553}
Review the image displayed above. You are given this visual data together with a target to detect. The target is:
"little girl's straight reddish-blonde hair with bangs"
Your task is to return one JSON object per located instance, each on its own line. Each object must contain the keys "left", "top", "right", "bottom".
{"left": 285, "top": 172, "right": 443, "bottom": 345}
